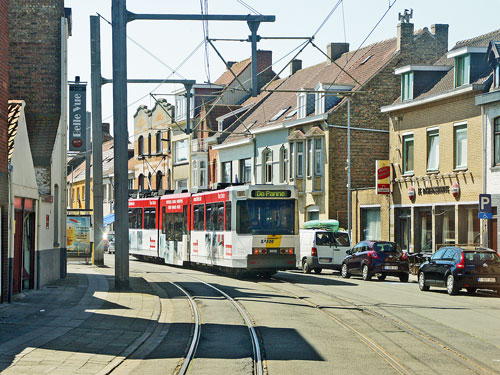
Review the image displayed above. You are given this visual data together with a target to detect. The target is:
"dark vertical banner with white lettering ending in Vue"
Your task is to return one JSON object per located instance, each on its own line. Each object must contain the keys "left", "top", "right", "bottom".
{"left": 69, "top": 84, "right": 87, "bottom": 151}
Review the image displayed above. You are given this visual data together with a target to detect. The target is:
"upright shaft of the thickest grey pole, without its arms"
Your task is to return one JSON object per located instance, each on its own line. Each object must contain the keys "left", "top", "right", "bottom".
{"left": 111, "top": 0, "right": 129, "bottom": 289}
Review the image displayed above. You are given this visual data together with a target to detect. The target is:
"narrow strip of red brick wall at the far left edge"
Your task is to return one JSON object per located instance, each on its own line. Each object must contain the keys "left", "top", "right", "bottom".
{"left": 0, "top": 0, "right": 9, "bottom": 302}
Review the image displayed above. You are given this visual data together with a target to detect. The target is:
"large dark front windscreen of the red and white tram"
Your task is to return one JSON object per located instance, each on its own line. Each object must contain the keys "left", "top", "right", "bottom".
{"left": 236, "top": 199, "right": 296, "bottom": 234}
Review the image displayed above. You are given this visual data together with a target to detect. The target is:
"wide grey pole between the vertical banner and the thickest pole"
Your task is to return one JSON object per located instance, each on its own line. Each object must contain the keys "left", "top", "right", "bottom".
{"left": 90, "top": 16, "right": 104, "bottom": 266}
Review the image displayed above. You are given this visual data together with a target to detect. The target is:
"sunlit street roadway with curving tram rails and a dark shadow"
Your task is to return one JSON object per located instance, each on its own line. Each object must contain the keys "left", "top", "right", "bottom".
{"left": 114, "top": 257, "right": 500, "bottom": 375}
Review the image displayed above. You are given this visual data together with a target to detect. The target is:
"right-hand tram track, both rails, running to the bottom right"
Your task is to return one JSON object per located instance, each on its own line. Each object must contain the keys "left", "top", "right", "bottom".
{"left": 266, "top": 277, "right": 495, "bottom": 375}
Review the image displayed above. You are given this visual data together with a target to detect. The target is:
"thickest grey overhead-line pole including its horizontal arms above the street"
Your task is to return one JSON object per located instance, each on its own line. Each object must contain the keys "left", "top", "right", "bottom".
{"left": 110, "top": 0, "right": 276, "bottom": 289}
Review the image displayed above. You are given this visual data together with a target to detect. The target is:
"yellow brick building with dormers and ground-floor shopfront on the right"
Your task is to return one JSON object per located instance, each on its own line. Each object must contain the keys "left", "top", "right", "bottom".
{"left": 353, "top": 31, "right": 500, "bottom": 252}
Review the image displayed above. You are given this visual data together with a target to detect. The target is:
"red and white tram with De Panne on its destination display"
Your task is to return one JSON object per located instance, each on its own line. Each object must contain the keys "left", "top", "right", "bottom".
{"left": 129, "top": 185, "right": 299, "bottom": 274}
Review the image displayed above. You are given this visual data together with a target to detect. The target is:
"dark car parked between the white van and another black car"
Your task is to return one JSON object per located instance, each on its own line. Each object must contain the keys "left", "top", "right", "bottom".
{"left": 342, "top": 241, "right": 409, "bottom": 282}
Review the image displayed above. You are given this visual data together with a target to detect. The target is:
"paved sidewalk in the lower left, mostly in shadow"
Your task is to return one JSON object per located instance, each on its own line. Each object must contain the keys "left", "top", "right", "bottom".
{"left": 0, "top": 264, "right": 165, "bottom": 375}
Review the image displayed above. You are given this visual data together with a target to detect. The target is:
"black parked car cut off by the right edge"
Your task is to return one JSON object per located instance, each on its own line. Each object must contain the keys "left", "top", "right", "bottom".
{"left": 418, "top": 247, "right": 500, "bottom": 294}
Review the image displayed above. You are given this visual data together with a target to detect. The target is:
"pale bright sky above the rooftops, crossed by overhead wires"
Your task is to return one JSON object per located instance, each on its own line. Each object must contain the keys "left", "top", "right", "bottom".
{"left": 65, "top": 0, "right": 500, "bottom": 136}
